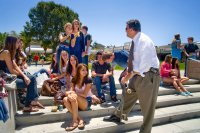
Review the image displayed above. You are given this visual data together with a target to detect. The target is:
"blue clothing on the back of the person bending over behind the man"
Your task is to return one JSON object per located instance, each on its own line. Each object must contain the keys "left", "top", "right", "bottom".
{"left": 113, "top": 50, "right": 129, "bottom": 69}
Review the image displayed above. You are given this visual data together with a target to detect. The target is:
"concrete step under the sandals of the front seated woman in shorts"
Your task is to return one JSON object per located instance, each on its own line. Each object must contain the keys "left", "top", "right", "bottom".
{"left": 16, "top": 103, "right": 200, "bottom": 133}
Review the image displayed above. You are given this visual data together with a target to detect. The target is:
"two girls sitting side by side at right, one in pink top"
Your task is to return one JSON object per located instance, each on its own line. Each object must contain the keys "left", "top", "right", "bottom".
{"left": 160, "top": 55, "right": 192, "bottom": 96}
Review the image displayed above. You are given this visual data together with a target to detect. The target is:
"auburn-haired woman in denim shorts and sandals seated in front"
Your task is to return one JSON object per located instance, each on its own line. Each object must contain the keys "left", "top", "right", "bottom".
{"left": 63, "top": 64, "right": 99, "bottom": 131}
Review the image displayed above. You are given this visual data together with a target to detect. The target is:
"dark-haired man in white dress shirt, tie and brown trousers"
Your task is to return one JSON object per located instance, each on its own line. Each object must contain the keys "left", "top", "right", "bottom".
{"left": 104, "top": 19, "right": 160, "bottom": 133}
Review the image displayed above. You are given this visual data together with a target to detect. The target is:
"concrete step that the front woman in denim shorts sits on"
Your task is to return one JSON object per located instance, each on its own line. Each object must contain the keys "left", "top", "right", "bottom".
{"left": 15, "top": 92, "right": 200, "bottom": 126}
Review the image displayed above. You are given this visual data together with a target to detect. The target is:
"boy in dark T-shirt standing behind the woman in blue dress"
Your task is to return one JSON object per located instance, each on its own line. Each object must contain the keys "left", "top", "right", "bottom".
{"left": 81, "top": 26, "right": 92, "bottom": 66}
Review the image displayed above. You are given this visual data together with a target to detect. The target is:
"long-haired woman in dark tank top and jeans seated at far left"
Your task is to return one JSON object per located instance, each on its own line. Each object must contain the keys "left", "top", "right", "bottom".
{"left": 0, "top": 36, "right": 44, "bottom": 112}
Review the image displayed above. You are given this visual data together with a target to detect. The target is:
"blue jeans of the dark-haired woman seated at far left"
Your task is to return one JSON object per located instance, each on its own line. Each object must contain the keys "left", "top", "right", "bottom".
{"left": 16, "top": 73, "right": 39, "bottom": 107}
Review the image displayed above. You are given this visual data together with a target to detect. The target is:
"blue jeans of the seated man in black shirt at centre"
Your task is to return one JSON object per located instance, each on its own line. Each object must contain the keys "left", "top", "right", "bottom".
{"left": 94, "top": 76, "right": 116, "bottom": 98}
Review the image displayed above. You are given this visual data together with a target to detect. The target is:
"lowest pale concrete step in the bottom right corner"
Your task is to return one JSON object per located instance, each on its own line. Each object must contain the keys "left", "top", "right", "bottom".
{"left": 127, "top": 118, "right": 200, "bottom": 133}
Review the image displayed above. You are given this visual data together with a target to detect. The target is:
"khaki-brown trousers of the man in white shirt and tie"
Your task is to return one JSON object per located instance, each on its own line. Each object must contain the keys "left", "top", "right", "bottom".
{"left": 114, "top": 72, "right": 160, "bottom": 133}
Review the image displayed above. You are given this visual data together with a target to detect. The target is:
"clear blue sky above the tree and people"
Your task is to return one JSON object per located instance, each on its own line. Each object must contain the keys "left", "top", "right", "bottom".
{"left": 0, "top": 0, "right": 200, "bottom": 46}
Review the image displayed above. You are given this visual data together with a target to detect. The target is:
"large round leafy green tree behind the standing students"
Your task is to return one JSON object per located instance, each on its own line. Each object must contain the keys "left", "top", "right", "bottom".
{"left": 29, "top": 1, "right": 78, "bottom": 51}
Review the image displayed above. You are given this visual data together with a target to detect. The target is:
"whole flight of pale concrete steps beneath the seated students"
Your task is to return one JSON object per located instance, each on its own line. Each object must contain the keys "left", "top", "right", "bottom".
{"left": 0, "top": 65, "right": 200, "bottom": 133}
